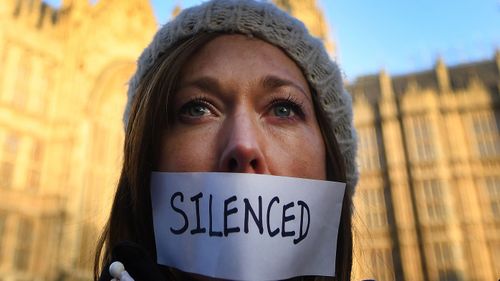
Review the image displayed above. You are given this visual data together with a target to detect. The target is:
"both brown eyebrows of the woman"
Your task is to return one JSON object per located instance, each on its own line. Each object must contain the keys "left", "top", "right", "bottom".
{"left": 180, "top": 75, "right": 311, "bottom": 100}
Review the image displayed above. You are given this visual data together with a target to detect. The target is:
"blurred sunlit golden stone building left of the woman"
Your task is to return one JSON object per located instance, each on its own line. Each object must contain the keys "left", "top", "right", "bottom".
{"left": 0, "top": 0, "right": 157, "bottom": 281}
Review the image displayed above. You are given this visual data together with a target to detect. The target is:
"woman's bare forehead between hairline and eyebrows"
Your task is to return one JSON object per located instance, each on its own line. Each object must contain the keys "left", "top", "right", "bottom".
{"left": 181, "top": 34, "right": 308, "bottom": 88}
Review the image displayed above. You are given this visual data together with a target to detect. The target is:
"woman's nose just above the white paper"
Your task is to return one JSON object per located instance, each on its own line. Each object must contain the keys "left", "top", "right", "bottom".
{"left": 219, "top": 111, "right": 270, "bottom": 174}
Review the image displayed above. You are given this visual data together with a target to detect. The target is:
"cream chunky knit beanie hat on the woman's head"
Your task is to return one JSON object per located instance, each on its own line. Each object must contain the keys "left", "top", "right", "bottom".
{"left": 123, "top": 0, "right": 358, "bottom": 194}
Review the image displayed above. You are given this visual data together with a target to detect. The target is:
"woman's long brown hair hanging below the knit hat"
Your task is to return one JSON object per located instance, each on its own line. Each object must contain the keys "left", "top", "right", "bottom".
{"left": 94, "top": 33, "right": 352, "bottom": 280}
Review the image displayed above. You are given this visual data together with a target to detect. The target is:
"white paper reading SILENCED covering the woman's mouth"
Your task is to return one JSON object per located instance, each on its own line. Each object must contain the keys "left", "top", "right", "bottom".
{"left": 151, "top": 172, "right": 345, "bottom": 280}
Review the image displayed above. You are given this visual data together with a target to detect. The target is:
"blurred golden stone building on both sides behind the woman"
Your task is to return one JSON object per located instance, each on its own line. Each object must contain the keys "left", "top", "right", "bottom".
{"left": 0, "top": 0, "right": 500, "bottom": 281}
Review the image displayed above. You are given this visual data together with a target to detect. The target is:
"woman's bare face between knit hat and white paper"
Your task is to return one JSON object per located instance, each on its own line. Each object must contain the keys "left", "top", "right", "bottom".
{"left": 158, "top": 35, "right": 326, "bottom": 179}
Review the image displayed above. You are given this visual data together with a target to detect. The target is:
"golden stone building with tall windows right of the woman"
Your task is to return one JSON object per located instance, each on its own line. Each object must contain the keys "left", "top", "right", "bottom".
{"left": 348, "top": 51, "right": 500, "bottom": 281}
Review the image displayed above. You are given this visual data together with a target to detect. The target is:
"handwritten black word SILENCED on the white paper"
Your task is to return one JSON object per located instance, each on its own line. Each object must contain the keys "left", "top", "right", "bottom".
{"left": 170, "top": 191, "right": 311, "bottom": 244}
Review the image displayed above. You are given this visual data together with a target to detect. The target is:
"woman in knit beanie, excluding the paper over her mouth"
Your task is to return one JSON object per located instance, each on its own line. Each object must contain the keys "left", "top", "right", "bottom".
{"left": 95, "top": 0, "right": 357, "bottom": 280}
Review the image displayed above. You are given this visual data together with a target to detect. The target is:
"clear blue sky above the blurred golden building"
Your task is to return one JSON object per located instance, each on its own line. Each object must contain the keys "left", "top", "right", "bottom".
{"left": 46, "top": 0, "right": 500, "bottom": 81}
